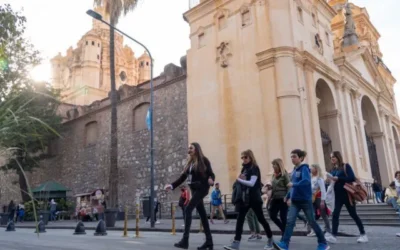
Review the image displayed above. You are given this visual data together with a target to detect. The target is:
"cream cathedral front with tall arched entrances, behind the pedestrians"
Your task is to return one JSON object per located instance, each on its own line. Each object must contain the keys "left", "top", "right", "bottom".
{"left": 184, "top": 0, "right": 400, "bottom": 190}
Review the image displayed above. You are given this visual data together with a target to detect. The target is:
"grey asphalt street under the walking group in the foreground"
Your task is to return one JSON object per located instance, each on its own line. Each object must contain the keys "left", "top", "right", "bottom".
{"left": 0, "top": 229, "right": 400, "bottom": 250}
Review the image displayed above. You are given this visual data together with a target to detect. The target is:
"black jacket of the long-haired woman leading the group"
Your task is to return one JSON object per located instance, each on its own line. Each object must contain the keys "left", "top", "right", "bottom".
{"left": 171, "top": 157, "right": 215, "bottom": 190}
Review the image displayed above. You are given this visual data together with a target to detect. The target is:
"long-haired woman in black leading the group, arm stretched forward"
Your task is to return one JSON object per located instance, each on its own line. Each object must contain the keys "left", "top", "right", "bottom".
{"left": 165, "top": 142, "right": 215, "bottom": 250}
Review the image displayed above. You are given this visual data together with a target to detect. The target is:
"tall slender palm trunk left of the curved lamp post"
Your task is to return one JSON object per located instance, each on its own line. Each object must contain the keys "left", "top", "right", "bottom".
{"left": 108, "top": 18, "right": 118, "bottom": 208}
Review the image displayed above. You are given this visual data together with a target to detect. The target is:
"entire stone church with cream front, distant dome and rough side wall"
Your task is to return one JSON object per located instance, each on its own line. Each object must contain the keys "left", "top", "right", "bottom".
{"left": 1, "top": 0, "right": 400, "bottom": 205}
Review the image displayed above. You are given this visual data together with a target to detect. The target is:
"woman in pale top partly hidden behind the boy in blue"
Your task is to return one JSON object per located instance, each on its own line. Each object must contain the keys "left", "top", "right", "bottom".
{"left": 307, "top": 164, "right": 332, "bottom": 238}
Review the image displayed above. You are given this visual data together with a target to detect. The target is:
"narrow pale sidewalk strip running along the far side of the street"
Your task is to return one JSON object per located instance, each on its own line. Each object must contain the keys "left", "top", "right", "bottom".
{"left": 2, "top": 219, "right": 358, "bottom": 237}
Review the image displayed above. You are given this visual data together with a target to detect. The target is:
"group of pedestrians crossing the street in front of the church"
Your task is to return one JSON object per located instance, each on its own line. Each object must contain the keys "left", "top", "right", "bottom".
{"left": 165, "top": 143, "right": 368, "bottom": 250}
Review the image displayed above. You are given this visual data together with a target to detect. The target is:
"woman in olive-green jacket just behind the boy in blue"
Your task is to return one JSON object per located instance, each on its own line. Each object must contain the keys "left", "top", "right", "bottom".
{"left": 269, "top": 158, "right": 290, "bottom": 234}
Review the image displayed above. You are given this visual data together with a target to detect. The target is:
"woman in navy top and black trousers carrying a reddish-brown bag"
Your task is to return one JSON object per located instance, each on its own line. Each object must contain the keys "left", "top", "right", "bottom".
{"left": 327, "top": 151, "right": 368, "bottom": 243}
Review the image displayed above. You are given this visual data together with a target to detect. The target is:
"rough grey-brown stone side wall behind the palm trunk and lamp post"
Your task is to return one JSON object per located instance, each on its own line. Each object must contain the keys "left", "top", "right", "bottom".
{"left": 29, "top": 58, "right": 188, "bottom": 211}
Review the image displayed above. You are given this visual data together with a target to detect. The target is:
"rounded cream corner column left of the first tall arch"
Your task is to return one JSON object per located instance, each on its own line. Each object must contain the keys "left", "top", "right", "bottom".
{"left": 275, "top": 55, "right": 305, "bottom": 157}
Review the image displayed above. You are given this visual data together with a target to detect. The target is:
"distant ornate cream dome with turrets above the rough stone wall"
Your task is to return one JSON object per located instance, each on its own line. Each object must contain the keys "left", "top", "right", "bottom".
{"left": 51, "top": 5, "right": 150, "bottom": 105}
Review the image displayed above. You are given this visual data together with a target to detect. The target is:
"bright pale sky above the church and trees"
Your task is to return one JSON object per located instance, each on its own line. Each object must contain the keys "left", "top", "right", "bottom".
{"left": 0, "top": 0, "right": 400, "bottom": 107}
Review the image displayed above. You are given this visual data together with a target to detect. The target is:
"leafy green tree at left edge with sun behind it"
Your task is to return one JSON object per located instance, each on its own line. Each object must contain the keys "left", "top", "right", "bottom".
{"left": 0, "top": 5, "right": 61, "bottom": 201}
